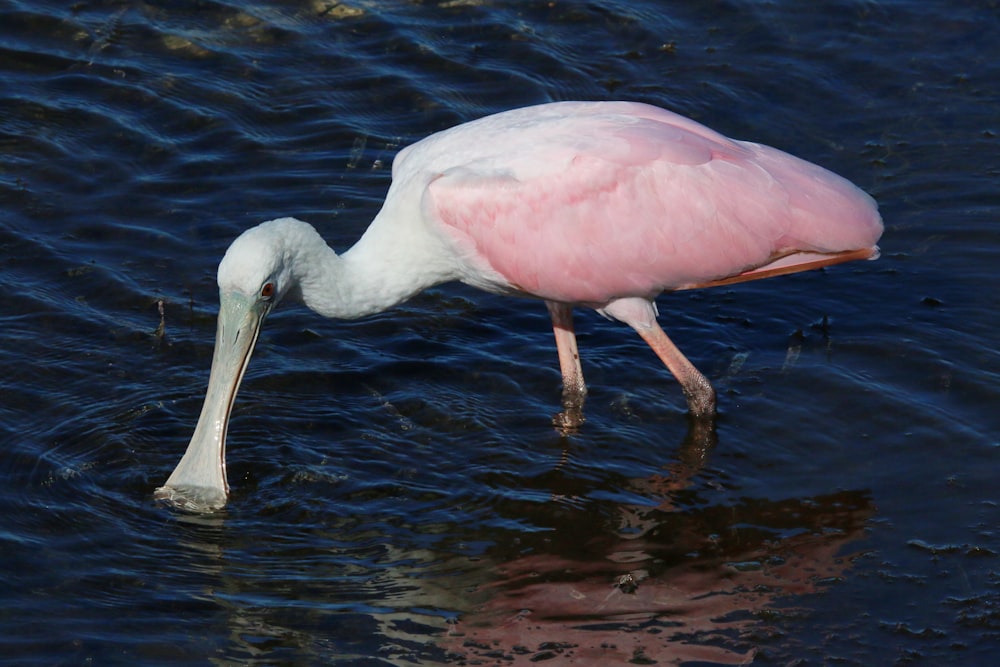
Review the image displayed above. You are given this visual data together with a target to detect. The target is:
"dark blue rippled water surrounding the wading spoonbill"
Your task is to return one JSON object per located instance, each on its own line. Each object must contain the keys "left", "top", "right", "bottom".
{"left": 0, "top": 0, "right": 1000, "bottom": 665}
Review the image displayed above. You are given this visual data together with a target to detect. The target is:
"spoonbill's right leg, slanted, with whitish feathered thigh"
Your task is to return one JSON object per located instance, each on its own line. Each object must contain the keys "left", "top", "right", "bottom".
{"left": 600, "top": 298, "right": 715, "bottom": 421}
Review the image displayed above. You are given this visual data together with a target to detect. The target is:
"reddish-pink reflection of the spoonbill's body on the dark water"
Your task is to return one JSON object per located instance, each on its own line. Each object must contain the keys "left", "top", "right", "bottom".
{"left": 445, "top": 424, "right": 874, "bottom": 665}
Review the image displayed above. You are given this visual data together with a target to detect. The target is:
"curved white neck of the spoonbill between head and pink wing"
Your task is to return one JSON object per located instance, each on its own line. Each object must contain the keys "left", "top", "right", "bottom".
{"left": 297, "top": 216, "right": 455, "bottom": 319}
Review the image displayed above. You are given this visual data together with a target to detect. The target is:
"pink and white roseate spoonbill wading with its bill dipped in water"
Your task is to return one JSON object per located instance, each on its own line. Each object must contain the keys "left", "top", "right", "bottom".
{"left": 157, "top": 102, "right": 882, "bottom": 509}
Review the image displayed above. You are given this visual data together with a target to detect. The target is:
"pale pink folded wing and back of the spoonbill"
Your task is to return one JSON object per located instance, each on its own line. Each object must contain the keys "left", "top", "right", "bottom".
{"left": 410, "top": 103, "right": 882, "bottom": 307}
